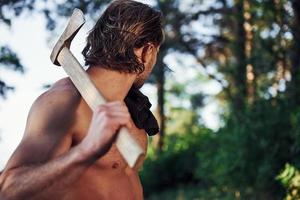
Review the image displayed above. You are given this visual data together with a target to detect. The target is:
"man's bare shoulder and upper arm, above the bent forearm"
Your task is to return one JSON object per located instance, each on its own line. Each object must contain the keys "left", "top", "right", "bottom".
{"left": 0, "top": 79, "right": 81, "bottom": 170}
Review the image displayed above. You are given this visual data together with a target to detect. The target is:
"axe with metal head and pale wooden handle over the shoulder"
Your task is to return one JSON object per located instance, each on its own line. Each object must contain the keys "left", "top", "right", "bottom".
{"left": 50, "top": 8, "right": 145, "bottom": 167}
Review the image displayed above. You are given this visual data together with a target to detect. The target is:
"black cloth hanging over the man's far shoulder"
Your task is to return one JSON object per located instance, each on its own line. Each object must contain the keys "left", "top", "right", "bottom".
{"left": 124, "top": 87, "right": 159, "bottom": 136}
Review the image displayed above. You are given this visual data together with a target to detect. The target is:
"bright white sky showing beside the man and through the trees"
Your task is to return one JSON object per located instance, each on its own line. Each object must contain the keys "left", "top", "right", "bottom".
{"left": 0, "top": 2, "right": 219, "bottom": 170}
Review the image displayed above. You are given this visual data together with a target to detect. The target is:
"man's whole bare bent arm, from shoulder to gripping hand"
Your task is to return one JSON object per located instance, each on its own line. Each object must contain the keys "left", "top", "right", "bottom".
{"left": 0, "top": 89, "right": 129, "bottom": 200}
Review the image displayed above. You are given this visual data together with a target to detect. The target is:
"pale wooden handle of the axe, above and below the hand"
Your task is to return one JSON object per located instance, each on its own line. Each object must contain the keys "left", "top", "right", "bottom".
{"left": 57, "top": 47, "right": 145, "bottom": 167}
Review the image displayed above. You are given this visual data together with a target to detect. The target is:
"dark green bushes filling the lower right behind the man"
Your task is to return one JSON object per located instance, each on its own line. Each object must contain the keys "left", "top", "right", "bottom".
{"left": 141, "top": 99, "right": 300, "bottom": 200}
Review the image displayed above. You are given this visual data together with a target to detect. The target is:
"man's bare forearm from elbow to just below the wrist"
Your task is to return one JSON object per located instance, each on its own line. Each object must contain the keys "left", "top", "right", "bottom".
{"left": 0, "top": 146, "right": 92, "bottom": 200}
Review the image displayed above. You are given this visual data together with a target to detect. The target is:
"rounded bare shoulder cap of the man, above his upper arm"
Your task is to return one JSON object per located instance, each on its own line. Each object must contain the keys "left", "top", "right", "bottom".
{"left": 28, "top": 78, "right": 81, "bottom": 134}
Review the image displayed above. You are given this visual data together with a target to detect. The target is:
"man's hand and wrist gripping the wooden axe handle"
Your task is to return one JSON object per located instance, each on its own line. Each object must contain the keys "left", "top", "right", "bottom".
{"left": 79, "top": 101, "right": 132, "bottom": 161}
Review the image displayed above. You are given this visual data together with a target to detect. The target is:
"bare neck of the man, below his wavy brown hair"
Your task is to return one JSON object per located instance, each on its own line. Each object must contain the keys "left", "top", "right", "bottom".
{"left": 87, "top": 66, "right": 136, "bottom": 101}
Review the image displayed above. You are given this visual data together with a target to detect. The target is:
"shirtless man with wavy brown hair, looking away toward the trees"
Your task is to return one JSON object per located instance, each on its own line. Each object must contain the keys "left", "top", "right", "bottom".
{"left": 0, "top": 0, "right": 163, "bottom": 200}
